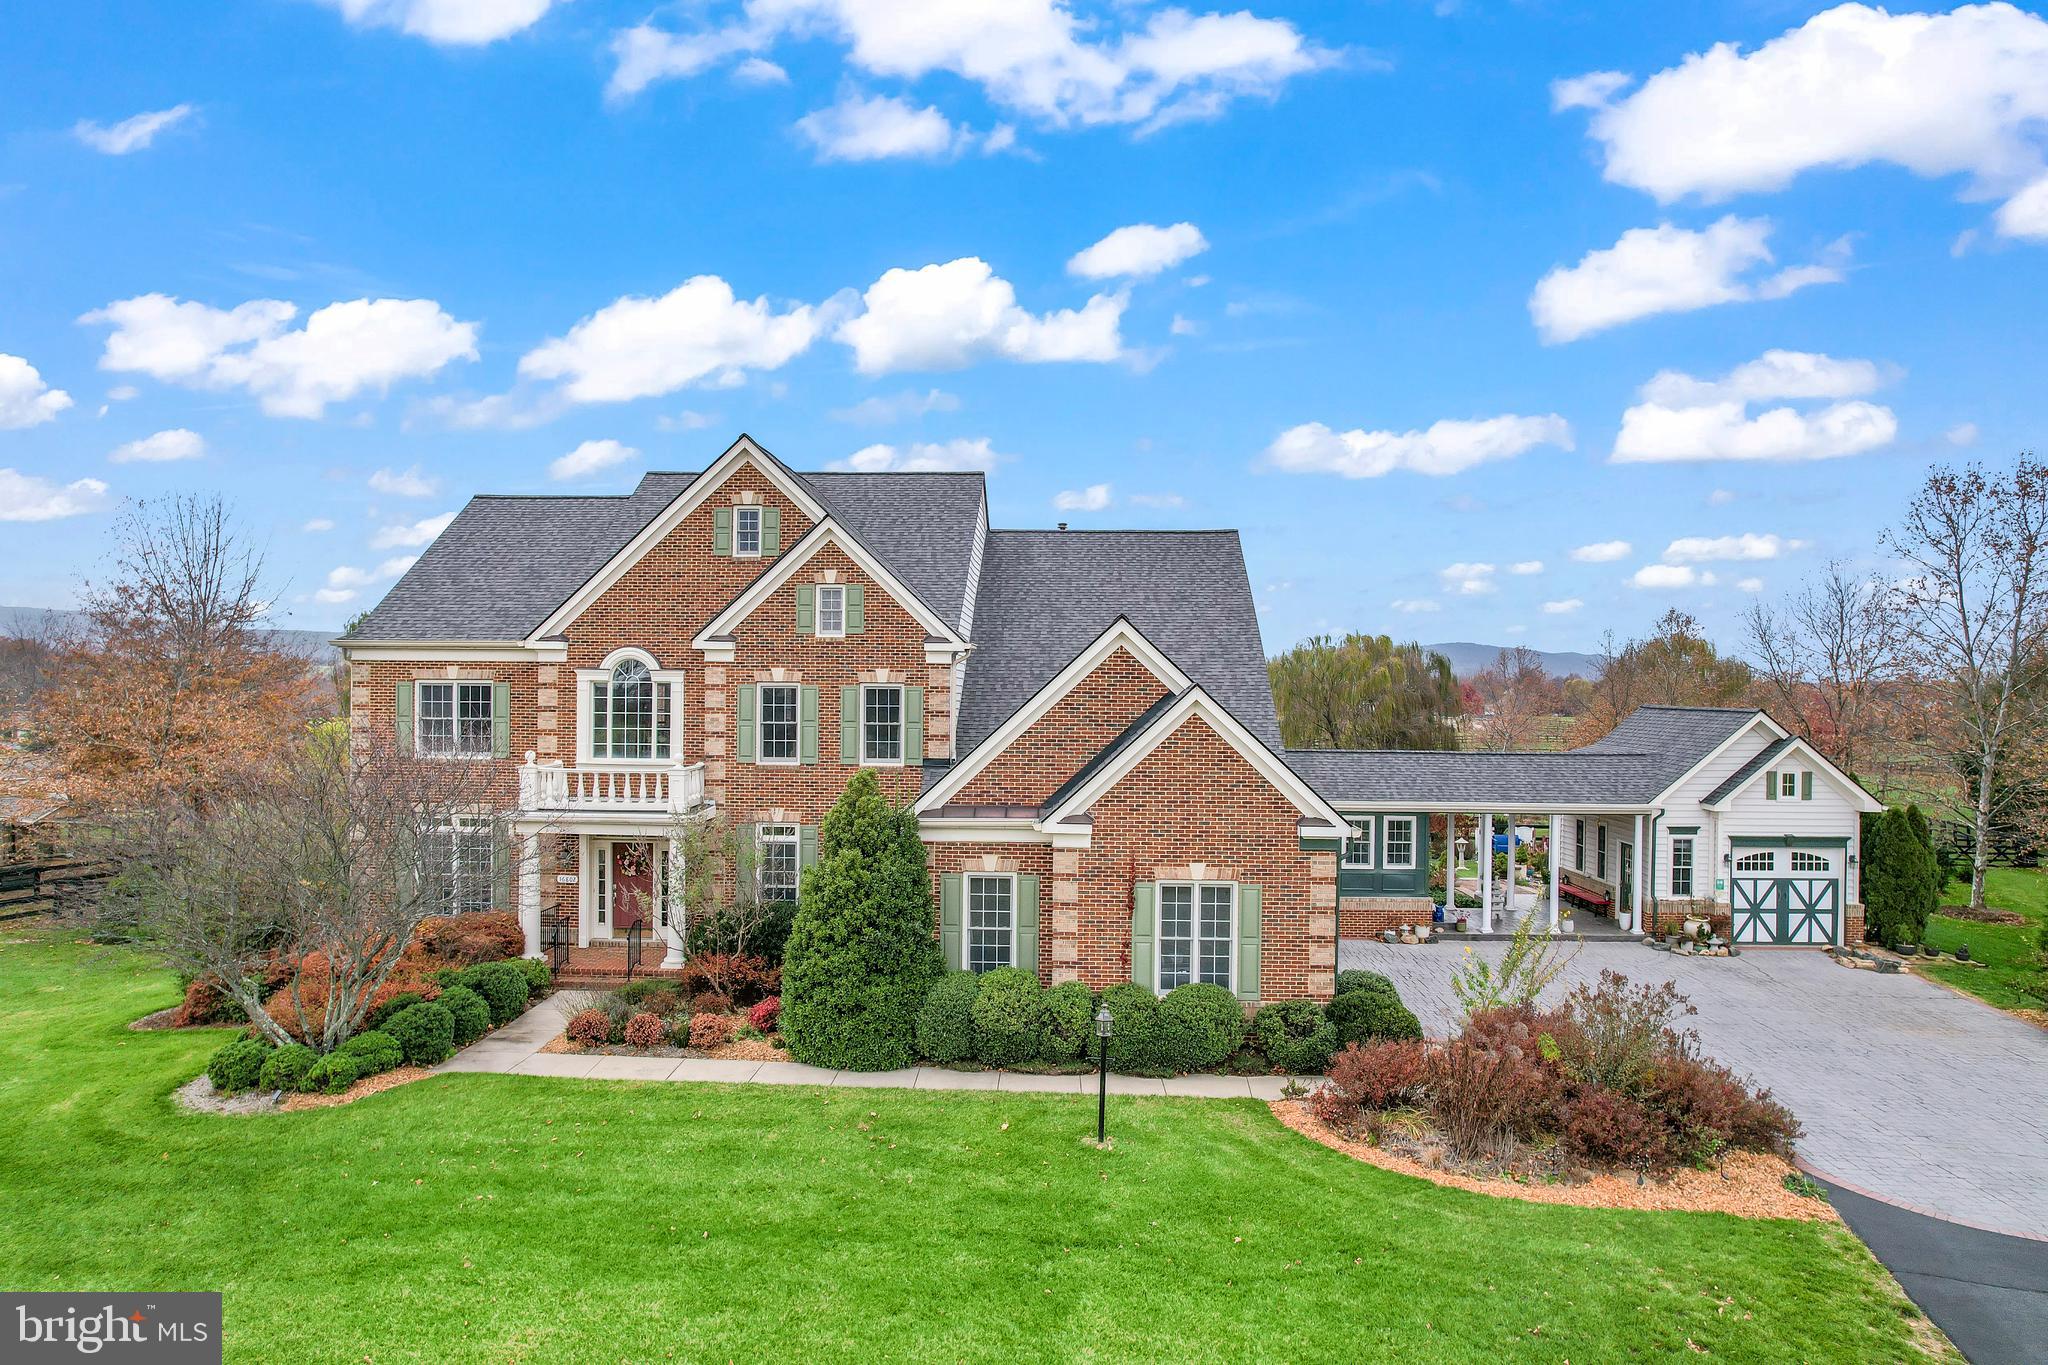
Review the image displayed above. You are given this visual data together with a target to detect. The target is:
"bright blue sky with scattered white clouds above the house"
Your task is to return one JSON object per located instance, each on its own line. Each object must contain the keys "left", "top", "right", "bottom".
{"left": 0, "top": 0, "right": 2048, "bottom": 649}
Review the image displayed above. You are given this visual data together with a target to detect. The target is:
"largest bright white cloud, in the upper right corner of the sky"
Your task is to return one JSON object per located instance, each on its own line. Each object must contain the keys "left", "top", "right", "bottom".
{"left": 1587, "top": 4, "right": 2048, "bottom": 235}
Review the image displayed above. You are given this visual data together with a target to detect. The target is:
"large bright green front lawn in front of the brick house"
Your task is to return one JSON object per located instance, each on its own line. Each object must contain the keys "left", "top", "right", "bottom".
{"left": 0, "top": 933, "right": 1941, "bottom": 1363}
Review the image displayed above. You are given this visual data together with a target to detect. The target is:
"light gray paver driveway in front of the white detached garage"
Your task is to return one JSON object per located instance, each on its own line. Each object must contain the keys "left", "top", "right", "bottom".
{"left": 1339, "top": 939, "right": 2048, "bottom": 1238}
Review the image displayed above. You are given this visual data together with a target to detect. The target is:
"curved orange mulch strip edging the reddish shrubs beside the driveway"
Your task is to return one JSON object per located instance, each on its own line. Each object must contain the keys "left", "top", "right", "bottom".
{"left": 1270, "top": 1099, "right": 1841, "bottom": 1222}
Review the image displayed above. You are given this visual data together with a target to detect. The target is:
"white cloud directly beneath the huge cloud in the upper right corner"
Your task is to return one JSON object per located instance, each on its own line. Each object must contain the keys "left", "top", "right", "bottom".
{"left": 1530, "top": 215, "right": 1849, "bottom": 344}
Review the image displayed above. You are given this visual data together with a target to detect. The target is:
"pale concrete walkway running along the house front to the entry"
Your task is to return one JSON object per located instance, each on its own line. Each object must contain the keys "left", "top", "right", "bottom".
{"left": 434, "top": 990, "right": 1321, "bottom": 1099}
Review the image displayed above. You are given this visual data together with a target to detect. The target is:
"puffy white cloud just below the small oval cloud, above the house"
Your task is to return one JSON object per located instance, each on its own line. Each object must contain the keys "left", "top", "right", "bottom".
{"left": 834, "top": 256, "right": 1124, "bottom": 375}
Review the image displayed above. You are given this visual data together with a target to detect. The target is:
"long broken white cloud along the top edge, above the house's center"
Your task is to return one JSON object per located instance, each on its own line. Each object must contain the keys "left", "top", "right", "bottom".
{"left": 608, "top": 0, "right": 1339, "bottom": 133}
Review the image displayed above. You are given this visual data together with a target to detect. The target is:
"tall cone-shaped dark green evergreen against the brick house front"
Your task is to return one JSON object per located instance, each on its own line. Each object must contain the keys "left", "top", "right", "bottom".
{"left": 782, "top": 769, "right": 940, "bottom": 1070}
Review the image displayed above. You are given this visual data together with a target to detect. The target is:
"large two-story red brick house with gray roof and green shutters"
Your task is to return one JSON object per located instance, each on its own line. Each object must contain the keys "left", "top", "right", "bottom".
{"left": 338, "top": 436, "right": 1868, "bottom": 1001}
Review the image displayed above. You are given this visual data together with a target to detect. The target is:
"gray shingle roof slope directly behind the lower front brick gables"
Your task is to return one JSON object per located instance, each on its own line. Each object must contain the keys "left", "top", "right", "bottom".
{"left": 956, "top": 530, "right": 1280, "bottom": 757}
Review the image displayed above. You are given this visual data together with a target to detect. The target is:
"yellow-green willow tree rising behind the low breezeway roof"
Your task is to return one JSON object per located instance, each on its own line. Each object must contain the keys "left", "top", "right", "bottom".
{"left": 1266, "top": 634, "right": 1464, "bottom": 749}
